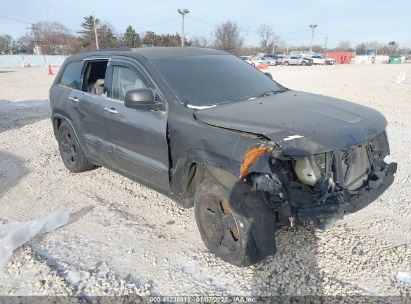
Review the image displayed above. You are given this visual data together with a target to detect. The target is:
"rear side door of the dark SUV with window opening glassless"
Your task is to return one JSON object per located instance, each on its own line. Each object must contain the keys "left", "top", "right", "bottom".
{"left": 66, "top": 59, "right": 108, "bottom": 161}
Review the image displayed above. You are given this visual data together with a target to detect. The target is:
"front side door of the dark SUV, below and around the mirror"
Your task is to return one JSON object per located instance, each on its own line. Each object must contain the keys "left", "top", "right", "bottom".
{"left": 105, "top": 59, "right": 170, "bottom": 191}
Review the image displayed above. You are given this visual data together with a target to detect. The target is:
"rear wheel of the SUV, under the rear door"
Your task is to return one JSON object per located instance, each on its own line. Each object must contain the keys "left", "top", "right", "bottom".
{"left": 57, "top": 122, "right": 95, "bottom": 173}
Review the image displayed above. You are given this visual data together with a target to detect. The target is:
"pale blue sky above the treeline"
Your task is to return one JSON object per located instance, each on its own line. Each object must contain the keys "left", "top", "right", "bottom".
{"left": 0, "top": 0, "right": 411, "bottom": 48}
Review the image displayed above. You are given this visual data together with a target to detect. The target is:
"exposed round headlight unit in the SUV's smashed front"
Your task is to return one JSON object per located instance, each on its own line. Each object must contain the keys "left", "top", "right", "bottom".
{"left": 294, "top": 154, "right": 325, "bottom": 186}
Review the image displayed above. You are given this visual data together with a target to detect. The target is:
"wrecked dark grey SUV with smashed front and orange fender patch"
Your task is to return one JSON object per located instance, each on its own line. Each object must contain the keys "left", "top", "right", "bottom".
{"left": 50, "top": 47, "right": 396, "bottom": 266}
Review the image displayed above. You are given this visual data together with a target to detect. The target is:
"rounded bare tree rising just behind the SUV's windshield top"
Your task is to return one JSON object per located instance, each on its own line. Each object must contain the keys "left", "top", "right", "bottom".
{"left": 214, "top": 21, "right": 244, "bottom": 53}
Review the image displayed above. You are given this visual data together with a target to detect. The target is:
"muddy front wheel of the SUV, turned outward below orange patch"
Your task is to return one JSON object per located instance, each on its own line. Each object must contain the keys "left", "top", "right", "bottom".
{"left": 194, "top": 178, "right": 275, "bottom": 266}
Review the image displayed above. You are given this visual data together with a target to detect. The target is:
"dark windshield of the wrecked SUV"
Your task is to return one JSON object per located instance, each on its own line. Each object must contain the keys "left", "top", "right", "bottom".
{"left": 152, "top": 55, "right": 285, "bottom": 106}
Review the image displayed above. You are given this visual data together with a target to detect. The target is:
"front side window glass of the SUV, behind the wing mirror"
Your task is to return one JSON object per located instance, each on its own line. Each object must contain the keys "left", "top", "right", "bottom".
{"left": 110, "top": 66, "right": 150, "bottom": 101}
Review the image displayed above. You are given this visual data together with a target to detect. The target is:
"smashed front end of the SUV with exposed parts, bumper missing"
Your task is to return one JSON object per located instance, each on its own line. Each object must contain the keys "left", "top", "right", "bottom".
{"left": 242, "top": 131, "right": 397, "bottom": 228}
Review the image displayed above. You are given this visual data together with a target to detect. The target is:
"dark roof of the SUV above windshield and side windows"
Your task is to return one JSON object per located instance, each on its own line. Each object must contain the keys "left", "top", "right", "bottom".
{"left": 67, "top": 47, "right": 228, "bottom": 60}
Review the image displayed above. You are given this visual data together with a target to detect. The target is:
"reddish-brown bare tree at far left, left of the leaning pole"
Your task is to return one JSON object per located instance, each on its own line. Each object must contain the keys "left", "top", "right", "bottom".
{"left": 32, "top": 21, "right": 74, "bottom": 55}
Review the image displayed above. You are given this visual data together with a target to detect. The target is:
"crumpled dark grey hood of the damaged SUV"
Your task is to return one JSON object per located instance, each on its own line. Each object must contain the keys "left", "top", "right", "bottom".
{"left": 195, "top": 91, "right": 387, "bottom": 155}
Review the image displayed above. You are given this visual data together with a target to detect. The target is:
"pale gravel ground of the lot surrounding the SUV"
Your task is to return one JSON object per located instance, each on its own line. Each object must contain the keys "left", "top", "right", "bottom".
{"left": 0, "top": 65, "right": 411, "bottom": 297}
